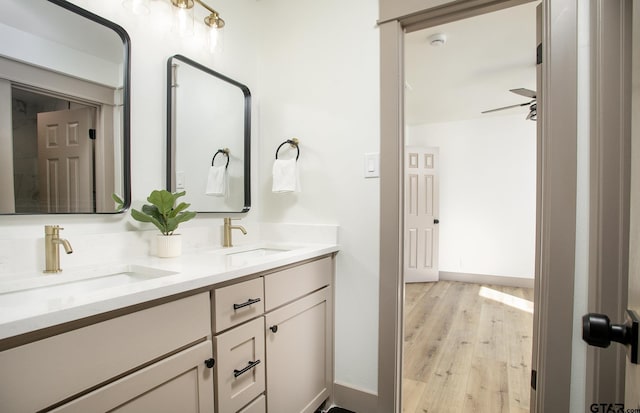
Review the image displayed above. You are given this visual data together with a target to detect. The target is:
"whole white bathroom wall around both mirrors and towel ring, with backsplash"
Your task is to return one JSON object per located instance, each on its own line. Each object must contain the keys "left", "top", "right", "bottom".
{"left": 0, "top": 0, "right": 379, "bottom": 393}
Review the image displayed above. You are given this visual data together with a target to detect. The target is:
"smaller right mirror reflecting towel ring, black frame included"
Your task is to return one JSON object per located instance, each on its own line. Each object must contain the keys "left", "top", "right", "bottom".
{"left": 167, "top": 55, "right": 251, "bottom": 213}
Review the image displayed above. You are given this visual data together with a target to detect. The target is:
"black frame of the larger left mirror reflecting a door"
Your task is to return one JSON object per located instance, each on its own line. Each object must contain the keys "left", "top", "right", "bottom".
{"left": 47, "top": 0, "right": 131, "bottom": 215}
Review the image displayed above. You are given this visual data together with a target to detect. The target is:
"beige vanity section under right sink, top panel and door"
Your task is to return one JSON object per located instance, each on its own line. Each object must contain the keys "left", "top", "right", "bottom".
{"left": 264, "top": 257, "right": 333, "bottom": 413}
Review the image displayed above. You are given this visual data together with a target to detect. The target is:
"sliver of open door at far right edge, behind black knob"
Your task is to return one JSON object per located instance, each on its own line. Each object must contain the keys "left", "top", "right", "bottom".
{"left": 625, "top": 2, "right": 640, "bottom": 411}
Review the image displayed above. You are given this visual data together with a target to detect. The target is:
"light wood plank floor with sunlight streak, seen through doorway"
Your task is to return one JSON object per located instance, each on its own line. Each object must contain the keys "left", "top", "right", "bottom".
{"left": 403, "top": 281, "right": 533, "bottom": 413}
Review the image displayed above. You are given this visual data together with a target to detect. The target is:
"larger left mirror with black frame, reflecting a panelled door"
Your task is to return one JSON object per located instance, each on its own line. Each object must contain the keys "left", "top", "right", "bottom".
{"left": 0, "top": 0, "right": 131, "bottom": 214}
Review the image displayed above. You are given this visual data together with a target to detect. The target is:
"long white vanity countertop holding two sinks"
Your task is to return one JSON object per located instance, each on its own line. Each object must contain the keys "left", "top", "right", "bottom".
{"left": 0, "top": 242, "right": 339, "bottom": 340}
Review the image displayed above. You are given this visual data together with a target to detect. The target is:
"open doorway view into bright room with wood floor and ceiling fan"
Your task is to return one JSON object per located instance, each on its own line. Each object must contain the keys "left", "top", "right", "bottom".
{"left": 403, "top": 2, "right": 537, "bottom": 413}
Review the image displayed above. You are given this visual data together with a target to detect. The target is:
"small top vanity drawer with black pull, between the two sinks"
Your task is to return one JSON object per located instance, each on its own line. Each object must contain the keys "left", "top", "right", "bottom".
{"left": 213, "top": 278, "right": 264, "bottom": 333}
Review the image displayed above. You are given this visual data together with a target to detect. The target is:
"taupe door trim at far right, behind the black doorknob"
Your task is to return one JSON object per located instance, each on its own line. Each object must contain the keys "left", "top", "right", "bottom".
{"left": 585, "top": 0, "right": 632, "bottom": 406}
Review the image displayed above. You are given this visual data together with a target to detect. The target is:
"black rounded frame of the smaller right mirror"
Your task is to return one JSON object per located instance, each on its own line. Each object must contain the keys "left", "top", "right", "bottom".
{"left": 167, "top": 54, "right": 251, "bottom": 213}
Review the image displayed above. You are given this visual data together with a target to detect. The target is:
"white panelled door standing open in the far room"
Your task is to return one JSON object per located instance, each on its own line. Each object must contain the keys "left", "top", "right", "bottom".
{"left": 404, "top": 146, "right": 440, "bottom": 282}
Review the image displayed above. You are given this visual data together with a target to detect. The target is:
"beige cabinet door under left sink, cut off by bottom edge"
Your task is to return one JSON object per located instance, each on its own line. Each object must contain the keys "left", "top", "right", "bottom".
{"left": 53, "top": 341, "right": 213, "bottom": 413}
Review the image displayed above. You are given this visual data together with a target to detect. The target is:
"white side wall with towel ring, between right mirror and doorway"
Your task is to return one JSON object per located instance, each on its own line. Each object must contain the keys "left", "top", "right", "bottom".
{"left": 256, "top": 0, "right": 379, "bottom": 393}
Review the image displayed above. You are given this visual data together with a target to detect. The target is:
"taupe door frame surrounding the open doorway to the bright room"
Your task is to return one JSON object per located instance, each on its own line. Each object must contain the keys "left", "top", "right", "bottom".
{"left": 378, "top": 0, "right": 578, "bottom": 413}
